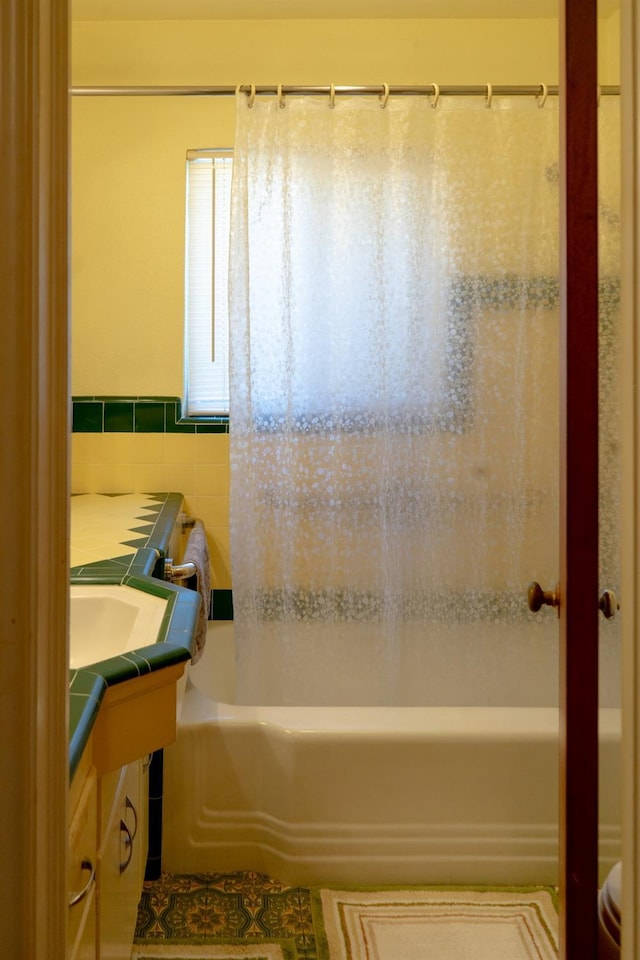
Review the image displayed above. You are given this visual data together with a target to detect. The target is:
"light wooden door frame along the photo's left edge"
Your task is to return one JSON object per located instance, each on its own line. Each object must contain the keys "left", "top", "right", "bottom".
{"left": 0, "top": 0, "right": 69, "bottom": 960}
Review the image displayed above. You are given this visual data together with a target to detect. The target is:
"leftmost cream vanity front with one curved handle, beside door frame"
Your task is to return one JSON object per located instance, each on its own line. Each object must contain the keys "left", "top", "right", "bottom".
{"left": 67, "top": 767, "right": 98, "bottom": 960}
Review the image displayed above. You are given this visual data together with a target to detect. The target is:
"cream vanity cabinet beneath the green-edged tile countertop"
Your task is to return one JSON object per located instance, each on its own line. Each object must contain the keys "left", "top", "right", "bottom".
{"left": 67, "top": 568, "right": 190, "bottom": 960}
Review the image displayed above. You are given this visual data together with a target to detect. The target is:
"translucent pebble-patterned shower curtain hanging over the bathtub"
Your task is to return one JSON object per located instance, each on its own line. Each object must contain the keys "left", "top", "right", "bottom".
{"left": 229, "top": 95, "right": 620, "bottom": 705}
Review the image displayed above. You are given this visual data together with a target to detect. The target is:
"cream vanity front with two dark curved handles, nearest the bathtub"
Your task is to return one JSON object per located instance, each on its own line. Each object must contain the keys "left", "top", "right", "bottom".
{"left": 98, "top": 761, "right": 146, "bottom": 960}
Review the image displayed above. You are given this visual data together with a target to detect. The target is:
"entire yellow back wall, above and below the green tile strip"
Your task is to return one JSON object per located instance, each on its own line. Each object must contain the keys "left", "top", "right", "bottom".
{"left": 72, "top": 18, "right": 617, "bottom": 588}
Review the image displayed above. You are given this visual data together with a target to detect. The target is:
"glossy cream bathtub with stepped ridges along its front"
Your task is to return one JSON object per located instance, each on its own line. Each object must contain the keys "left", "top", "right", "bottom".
{"left": 163, "top": 622, "right": 620, "bottom": 886}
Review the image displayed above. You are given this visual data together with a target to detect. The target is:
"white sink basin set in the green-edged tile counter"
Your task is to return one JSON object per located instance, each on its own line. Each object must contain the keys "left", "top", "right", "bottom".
{"left": 69, "top": 584, "right": 167, "bottom": 670}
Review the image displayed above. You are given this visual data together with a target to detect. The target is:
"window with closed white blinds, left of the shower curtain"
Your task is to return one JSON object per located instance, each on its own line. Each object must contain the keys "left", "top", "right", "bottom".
{"left": 185, "top": 149, "right": 233, "bottom": 417}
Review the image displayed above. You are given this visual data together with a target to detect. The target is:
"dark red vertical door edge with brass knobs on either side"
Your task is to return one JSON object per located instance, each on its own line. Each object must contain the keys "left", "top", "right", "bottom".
{"left": 560, "top": 0, "right": 598, "bottom": 960}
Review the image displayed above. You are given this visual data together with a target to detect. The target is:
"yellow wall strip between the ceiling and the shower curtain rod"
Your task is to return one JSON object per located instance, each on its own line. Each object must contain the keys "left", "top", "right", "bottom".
{"left": 73, "top": 19, "right": 558, "bottom": 85}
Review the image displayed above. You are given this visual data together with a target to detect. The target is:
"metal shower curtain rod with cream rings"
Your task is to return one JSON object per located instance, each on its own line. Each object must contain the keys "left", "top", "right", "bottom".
{"left": 71, "top": 83, "right": 620, "bottom": 99}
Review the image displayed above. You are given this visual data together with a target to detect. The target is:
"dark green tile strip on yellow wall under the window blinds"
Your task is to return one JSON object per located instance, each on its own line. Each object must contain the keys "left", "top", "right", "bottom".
{"left": 71, "top": 396, "right": 229, "bottom": 433}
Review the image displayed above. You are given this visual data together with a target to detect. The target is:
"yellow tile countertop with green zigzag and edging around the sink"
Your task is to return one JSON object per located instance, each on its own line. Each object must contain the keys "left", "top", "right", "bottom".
{"left": 69, "top": 493, "right": 200, "bottom": 779}
